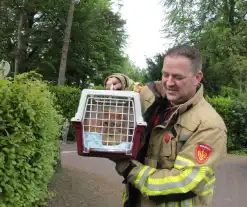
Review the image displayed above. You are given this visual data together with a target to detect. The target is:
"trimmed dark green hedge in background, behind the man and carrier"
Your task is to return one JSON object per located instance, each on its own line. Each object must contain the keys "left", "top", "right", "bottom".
{"left": 51, "top": 83, "right": 247, "bottom": 150}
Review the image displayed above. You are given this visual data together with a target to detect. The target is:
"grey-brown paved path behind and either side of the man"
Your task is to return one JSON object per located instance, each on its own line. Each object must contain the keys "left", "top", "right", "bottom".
{"left": 51, "top": 144, "right": 247, "bottom": 207}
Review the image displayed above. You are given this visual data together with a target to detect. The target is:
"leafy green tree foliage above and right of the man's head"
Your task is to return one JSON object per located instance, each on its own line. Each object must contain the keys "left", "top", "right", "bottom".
{"left": 163, "top": 0, "right": 247, "bottom": 94}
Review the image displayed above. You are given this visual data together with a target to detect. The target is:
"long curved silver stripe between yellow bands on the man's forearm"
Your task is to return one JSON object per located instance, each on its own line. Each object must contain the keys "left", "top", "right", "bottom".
{"left": 144, "top": 168, "right": 200, "bottom": 191}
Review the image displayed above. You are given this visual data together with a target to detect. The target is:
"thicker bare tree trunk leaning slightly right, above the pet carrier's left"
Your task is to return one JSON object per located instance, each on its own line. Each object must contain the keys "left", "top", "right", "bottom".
{"left": 58, "top": 0, "right": 76, "bottom": 86}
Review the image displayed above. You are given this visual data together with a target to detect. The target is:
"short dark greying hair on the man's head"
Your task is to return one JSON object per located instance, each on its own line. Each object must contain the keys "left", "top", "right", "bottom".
{"left": 164, "top": 45, "right": 202, "bottom": 73}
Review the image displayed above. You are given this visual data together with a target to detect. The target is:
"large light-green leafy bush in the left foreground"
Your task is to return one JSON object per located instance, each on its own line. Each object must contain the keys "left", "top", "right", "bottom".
{"left": 0, "top": 72, "right": 62, "bottom": 207}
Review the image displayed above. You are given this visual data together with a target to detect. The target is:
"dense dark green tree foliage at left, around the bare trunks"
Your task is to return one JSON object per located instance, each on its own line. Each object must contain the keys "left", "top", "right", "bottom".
{"left": 0, "top": 0, "right": 127, "bottom": 88}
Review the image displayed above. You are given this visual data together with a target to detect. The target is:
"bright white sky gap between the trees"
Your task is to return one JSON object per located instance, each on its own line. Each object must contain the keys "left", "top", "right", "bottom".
{"left": 113, "top": 0, "right": 174, "bottom": 68}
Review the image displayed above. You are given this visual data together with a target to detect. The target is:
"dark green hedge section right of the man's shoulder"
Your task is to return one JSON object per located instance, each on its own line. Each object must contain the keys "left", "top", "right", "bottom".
{"left": 207, "top": 97, "right": 247, "bottom": 151}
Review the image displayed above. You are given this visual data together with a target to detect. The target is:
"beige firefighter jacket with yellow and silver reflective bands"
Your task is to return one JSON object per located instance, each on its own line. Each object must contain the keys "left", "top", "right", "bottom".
{"left": 105, "top": 74, "right": 227, "bottom": 207}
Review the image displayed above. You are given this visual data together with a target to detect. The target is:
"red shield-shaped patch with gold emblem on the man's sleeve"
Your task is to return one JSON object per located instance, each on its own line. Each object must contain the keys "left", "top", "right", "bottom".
{"left": 195, "top": 144, "right": 212, "bottom": 164}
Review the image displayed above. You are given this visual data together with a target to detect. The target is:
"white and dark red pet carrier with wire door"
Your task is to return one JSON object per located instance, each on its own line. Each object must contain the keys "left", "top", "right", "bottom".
{"left": 71, "top": 89, "right": 146, "bottom": 158}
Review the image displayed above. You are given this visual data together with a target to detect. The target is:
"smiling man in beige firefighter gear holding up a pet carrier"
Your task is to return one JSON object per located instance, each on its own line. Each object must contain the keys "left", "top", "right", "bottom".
{"left": 105, "top": 46, "right": 227, "bottom": 207}
